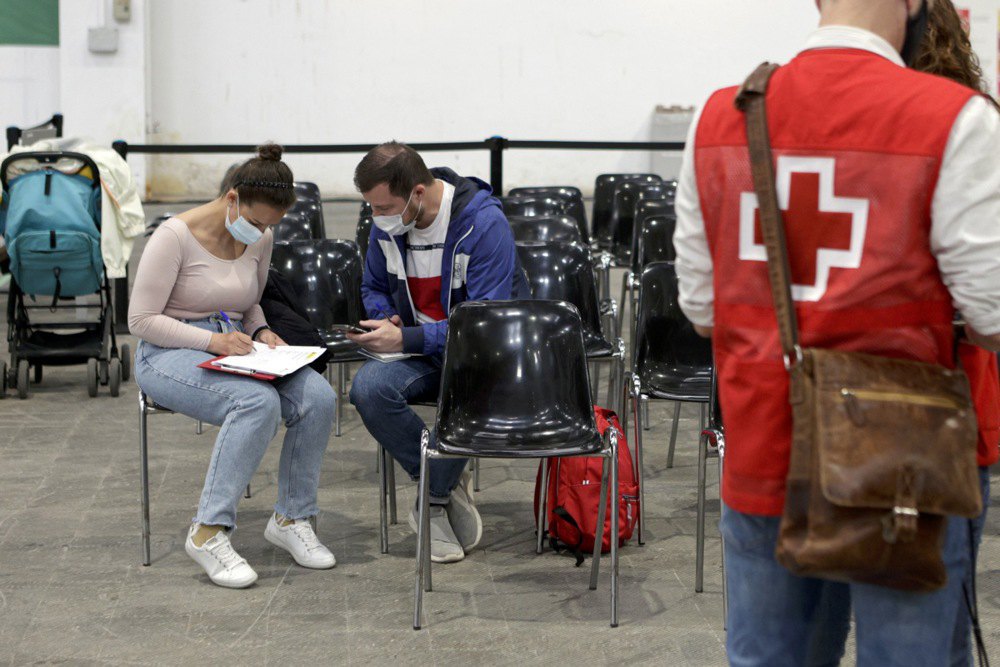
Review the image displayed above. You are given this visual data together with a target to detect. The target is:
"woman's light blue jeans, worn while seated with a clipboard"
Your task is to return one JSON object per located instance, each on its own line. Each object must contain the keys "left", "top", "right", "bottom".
{"left": 135, "top": 320, "right": 337, "bottom": 528}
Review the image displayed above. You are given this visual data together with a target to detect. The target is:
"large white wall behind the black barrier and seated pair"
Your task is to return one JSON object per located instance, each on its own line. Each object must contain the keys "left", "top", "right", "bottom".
{"left": 148, "top": 0, "right": 817, "bottom": 196}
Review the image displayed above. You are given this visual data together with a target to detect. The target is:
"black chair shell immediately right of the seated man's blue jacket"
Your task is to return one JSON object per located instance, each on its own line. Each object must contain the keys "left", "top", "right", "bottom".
{"left": 517, "top": 242, "right": 608, "bottom": 350}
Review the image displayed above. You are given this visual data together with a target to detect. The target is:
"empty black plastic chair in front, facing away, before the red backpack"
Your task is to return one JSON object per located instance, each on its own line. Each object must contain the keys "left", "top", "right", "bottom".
{"left": 413, "top": 300, "right": 620, "bottom": 630}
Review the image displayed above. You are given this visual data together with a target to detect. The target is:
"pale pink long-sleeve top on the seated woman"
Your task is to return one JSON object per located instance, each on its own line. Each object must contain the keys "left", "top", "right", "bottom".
{"left": 128, "top": 218, "right": 273, "bottom": 350}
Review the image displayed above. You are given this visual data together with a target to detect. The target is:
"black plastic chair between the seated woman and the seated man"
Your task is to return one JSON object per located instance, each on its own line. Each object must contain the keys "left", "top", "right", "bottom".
{"left": 271, "top": 239, "right": 367, "bottom": 436}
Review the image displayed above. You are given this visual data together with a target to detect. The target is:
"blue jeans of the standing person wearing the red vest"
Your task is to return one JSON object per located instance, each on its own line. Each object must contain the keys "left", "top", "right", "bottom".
{"left": 720, "top": 505, "right": 969, "bottom": 667}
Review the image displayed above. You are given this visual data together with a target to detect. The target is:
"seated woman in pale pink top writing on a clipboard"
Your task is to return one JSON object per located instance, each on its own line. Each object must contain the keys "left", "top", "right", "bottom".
{"left": 128, "top": 144, "right": 336, "bottom": 588}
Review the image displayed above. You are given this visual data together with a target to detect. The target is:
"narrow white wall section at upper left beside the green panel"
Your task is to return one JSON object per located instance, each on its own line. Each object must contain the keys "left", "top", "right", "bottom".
{"left": 59, "top": 0, "right": 148, "bottom": 192}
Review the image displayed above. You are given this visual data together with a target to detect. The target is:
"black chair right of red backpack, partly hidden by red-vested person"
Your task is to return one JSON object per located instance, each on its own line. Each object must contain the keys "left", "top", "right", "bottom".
{"left": 629, "top": 262, "right": 713, "bottom": 544}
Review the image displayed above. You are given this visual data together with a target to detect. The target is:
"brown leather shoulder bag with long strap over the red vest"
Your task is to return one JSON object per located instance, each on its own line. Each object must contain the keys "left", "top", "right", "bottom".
{"left": 736, "top": 63, "right": 982, "bottom": 591}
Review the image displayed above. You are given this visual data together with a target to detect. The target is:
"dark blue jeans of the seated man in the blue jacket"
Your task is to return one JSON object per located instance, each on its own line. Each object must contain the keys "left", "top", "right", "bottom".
{"left": 351, "top": 357, "right": 468, "bottom": 504}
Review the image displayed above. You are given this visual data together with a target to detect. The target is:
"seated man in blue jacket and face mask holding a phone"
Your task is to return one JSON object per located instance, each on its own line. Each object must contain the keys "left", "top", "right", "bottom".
{"left": 350, "top": 141, "right": 530, "bottom": 563}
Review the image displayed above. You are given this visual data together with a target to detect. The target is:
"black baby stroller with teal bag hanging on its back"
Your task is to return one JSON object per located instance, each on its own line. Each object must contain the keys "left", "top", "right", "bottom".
{"left": 0, "top": 152, "right": 131, "bottom": 398}
